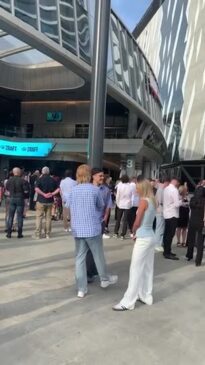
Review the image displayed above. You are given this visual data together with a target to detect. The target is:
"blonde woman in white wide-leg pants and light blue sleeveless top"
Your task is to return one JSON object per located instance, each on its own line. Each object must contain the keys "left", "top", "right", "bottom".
{"left": 113, "top": 179, "right": 156, "bottom": 311}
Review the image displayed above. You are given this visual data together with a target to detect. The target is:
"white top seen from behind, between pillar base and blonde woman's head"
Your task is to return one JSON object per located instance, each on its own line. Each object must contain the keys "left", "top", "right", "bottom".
{"left": 116, "top": 182, "right": 133, "bottom": 209}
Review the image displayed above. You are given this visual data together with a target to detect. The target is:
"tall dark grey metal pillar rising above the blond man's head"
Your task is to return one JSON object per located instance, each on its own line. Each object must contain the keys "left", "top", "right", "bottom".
{"left": 88, "top": 0, "right": 111, "bottom": 167}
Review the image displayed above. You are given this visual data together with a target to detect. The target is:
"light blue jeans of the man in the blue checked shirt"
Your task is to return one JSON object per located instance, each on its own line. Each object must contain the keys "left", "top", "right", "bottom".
{"left": 75, "top": 235, "right": 109, "bottom": 293}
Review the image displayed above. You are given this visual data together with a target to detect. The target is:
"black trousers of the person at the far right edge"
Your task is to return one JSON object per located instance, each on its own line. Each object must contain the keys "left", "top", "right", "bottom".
{"left": 186, "top": 225, "right": 204, "bottom": 264}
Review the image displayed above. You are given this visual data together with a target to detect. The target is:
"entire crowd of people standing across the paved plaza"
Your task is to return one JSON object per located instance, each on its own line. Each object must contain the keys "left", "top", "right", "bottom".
{"left": 0, "top": 165, "right": 205, "bottom": 311}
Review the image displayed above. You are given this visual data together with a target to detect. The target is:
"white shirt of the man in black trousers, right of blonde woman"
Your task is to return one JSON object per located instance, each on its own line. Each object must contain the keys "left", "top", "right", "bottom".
{"left": 163, "top": 184, "right": 182, "bottom": 219}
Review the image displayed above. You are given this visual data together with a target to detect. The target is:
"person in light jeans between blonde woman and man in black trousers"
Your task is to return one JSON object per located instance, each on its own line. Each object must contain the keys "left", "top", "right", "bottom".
{"left": 155, "top": 178, "right": 169, "bottom": 252}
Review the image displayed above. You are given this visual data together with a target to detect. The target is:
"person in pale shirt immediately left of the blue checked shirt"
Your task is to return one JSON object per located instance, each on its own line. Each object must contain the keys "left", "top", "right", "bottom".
{"left": 60, "top": 170, "right": 77, "bottom": 232}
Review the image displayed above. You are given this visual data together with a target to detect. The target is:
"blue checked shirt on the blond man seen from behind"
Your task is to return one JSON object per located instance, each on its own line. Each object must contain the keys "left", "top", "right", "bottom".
{"left": 65, "top": 183, "right": 104, "bottom": 238}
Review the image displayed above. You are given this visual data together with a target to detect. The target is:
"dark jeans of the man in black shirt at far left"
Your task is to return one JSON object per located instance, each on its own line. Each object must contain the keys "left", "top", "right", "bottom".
{"left": 7, "top": 198, "right": 24, "bottom": 234}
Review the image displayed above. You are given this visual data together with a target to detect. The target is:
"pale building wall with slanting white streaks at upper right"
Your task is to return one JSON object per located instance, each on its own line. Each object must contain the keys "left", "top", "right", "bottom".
{"left": 137, "top": 0, "right": 205, "bottom": 160}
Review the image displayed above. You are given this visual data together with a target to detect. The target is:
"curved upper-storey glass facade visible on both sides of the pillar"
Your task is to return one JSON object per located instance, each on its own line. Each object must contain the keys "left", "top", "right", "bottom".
{"left": 0, "top": 0, "right": 164, "bottom": 136}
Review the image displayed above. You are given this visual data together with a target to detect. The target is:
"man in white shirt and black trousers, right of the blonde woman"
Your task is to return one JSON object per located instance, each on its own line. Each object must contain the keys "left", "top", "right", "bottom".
{"left": 163, "top": 177, "right": 182, "bottom": 260}
